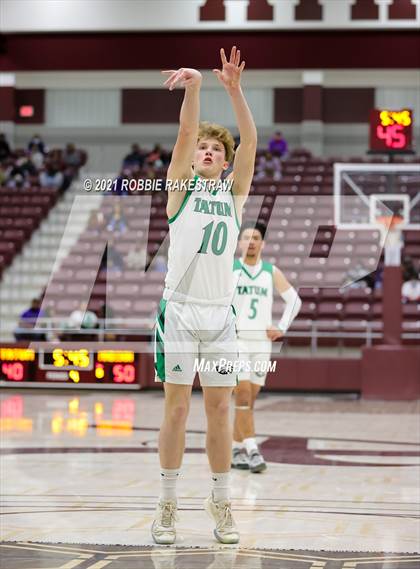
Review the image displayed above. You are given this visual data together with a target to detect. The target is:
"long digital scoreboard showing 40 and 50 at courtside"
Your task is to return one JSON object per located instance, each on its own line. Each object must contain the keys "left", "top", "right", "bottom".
{"left": 0, "top": 346, "right": 139, "bottom": 387}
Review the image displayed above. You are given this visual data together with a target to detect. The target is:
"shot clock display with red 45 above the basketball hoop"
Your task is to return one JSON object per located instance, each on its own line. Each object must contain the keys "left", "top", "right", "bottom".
{"left": 370, "top": 109, "right": 413, "bottom": 152}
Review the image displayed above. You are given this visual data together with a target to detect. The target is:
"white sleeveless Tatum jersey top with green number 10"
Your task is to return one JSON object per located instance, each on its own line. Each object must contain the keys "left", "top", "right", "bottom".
{"left": 163, "top": 176, "right": 240, "bottom": 306}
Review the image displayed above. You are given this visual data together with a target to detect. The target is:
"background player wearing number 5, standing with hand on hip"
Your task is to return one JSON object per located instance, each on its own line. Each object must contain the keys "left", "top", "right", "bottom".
{"left": 232, "top": 221, "right": 302, "bottom": 472}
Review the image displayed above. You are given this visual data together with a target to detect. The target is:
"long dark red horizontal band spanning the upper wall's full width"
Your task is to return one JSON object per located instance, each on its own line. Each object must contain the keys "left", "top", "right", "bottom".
{"left": 0, "top": 30, "right": 420, "bottom": 71}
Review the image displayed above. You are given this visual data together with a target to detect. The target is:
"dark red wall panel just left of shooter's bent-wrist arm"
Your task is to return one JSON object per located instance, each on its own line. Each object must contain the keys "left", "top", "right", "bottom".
{"left": 121, "top": 89, "right": 184, "bottom": 123}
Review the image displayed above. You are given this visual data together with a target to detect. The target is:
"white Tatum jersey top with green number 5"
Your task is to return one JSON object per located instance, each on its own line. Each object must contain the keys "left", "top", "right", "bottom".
{"left": 233, "top": 259, "right": 273, "bottom": 340}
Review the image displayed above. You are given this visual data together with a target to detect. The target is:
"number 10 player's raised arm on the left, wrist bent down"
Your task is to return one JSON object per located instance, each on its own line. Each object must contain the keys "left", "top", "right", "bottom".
{"left": 162, "top": 67, "right": 202, "bottom": 217}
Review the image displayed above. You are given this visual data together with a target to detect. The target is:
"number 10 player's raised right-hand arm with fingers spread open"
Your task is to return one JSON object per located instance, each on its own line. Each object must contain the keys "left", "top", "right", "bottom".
{"left": 213, "top": 46, "right": 257, "bottom": 199}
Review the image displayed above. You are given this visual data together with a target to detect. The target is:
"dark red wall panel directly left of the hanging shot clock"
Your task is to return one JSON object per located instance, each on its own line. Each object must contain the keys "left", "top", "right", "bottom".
{"left": 322, "top": 88, "right": 375, "bottom": 123}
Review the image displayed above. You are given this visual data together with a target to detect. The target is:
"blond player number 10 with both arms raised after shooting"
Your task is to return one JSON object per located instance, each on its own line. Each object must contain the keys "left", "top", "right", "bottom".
{"left": 152, "top": 47, "right": 257, "bottom": 544}
